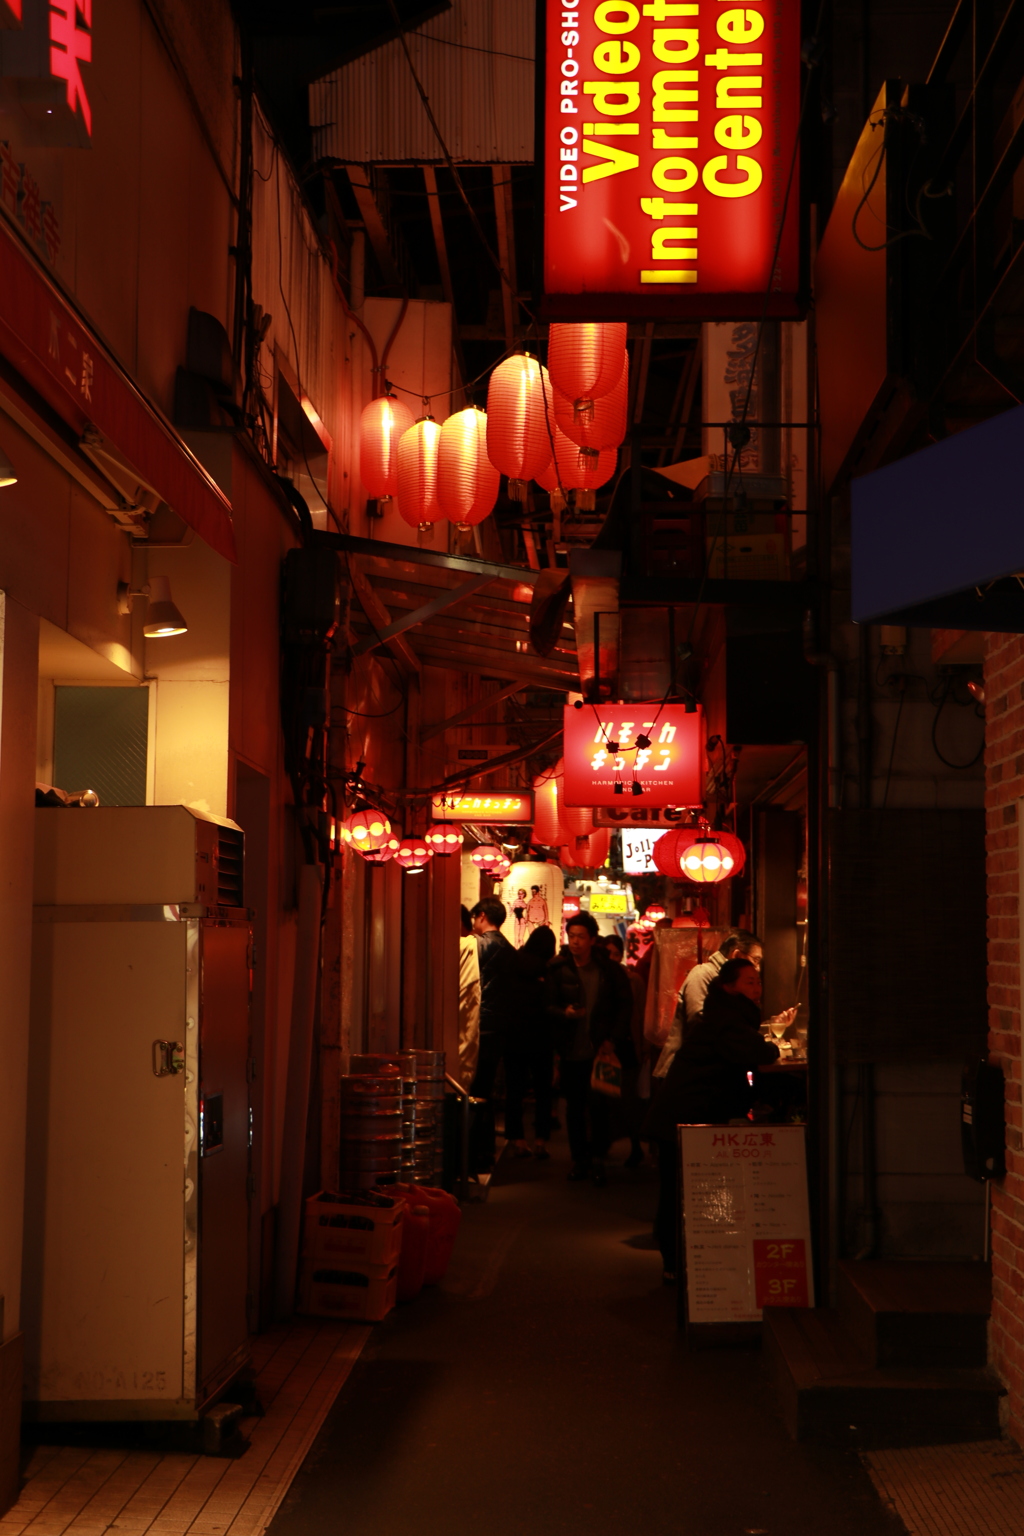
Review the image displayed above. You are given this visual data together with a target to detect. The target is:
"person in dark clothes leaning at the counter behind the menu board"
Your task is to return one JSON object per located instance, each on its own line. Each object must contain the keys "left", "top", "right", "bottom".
{"left": 642, "top": 960, "right": 780, "bottom": 1281}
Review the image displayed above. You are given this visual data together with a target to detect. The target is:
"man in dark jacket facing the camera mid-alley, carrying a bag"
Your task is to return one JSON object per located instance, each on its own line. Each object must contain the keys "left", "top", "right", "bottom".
{"left": 547, "top": 912, "right": 637, "bottom": 1186}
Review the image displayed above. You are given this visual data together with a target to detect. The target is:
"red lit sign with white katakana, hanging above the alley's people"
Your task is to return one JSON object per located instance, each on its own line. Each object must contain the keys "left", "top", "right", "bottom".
{"left": 562, "top": 700, "right": 705, "bottom": 809}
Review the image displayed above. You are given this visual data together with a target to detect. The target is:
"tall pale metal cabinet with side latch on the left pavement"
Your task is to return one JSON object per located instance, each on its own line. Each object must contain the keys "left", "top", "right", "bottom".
{"left": 23, "top": 806, "right": 252, "bottom": 1422}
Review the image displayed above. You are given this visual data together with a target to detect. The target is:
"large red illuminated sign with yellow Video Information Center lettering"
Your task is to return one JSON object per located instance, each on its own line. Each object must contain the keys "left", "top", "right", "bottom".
{"left": 542, "top": 0, "right": 800, "bottom": 319}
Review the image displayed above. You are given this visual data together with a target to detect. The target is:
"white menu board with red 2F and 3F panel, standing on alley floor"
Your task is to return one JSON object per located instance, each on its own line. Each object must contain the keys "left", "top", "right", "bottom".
{"left": 679, "top": 1126, "right": 814, "bottom": 1322}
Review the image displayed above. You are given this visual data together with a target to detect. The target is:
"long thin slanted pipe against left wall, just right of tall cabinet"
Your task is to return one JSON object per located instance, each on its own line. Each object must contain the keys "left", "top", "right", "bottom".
{"left": 273, "top": 863, "right": 324, "bottom": 1322}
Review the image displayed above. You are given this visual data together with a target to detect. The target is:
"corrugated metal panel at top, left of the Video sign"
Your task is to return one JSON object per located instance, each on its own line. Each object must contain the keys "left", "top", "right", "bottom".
{"left": 310, "top": 0, "right": 536, "bottom": 164}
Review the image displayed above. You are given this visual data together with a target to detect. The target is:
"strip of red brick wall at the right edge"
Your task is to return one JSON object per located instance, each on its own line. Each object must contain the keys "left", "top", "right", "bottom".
{"left": 984, "top": 634, "right": 1024, "bottom": 1444}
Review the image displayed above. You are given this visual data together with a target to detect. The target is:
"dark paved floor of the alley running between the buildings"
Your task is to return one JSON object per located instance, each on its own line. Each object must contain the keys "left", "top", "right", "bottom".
{"left": 270, "top": 1143, "right": 904, "bottom": 1536}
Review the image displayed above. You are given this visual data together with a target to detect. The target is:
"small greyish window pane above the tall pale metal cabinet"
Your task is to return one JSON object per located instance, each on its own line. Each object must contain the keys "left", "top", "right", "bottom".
{"left": 54, "top": 687, "right": 149, "bottom": 805}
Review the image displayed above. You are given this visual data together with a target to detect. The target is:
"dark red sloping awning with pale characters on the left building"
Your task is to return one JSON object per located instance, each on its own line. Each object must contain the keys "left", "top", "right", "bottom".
{"left": 0, "top": 218, "right": 238, "bottom": 561}
